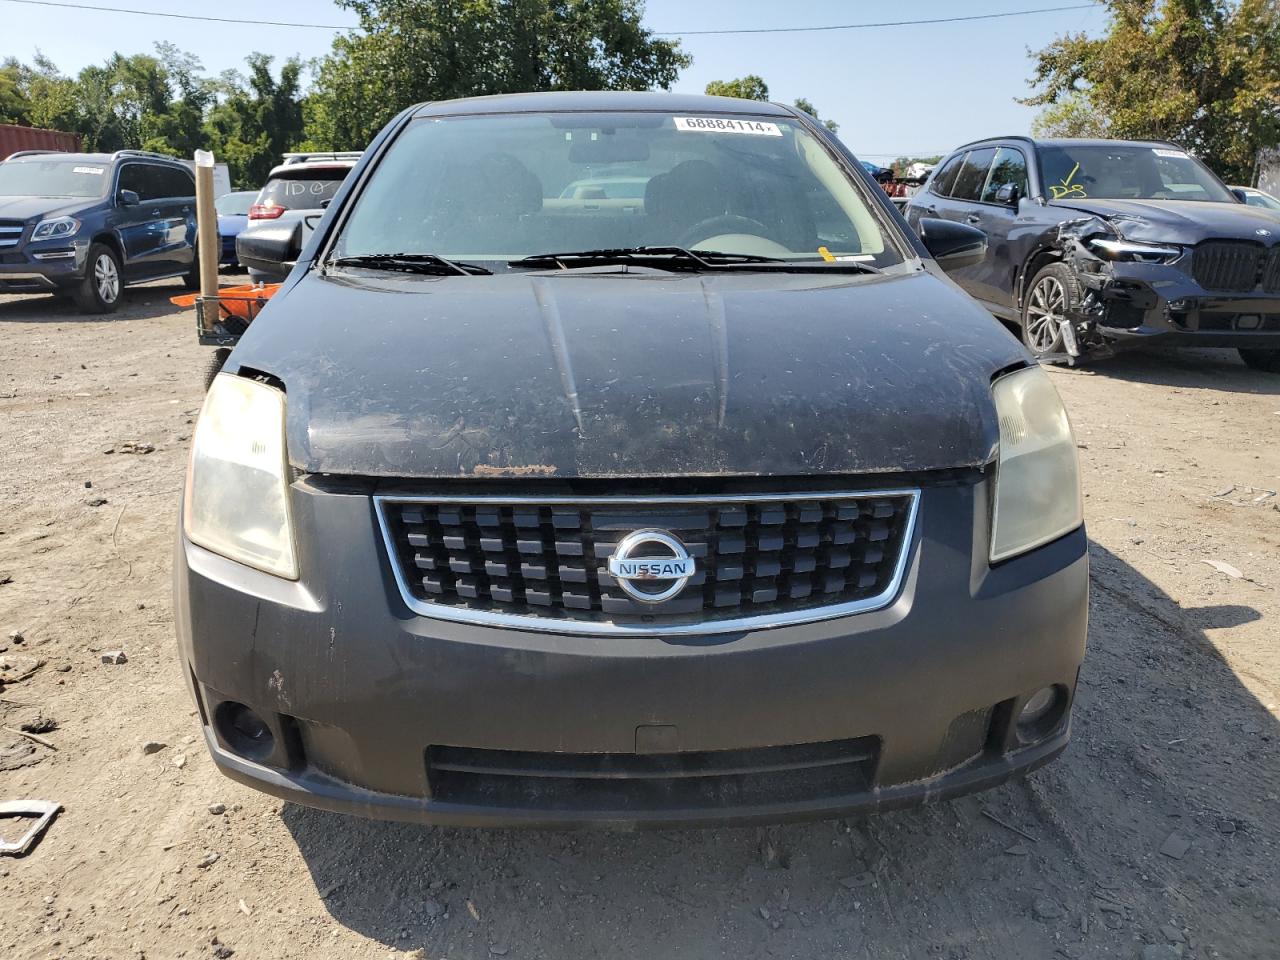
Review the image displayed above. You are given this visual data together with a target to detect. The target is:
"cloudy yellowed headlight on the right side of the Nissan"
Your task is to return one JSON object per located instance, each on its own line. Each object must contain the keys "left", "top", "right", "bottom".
{"left": 991, "top": 366, "right": 1084, "bottom": 563}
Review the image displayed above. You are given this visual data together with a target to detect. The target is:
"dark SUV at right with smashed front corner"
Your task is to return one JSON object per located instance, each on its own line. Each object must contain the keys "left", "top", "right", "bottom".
{"left": 905, "top": 137, "right": 1280, "bottom": 372}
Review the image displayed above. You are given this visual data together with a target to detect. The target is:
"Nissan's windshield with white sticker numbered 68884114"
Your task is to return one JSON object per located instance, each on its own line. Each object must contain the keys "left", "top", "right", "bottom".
{"left": 333, "top": 113, "right": 900, "bottom": 268}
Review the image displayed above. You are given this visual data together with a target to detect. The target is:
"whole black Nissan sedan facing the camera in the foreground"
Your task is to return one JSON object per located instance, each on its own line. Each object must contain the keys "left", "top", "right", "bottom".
{"left": 174, "top": 93, "right": 1088, "bottom": 828}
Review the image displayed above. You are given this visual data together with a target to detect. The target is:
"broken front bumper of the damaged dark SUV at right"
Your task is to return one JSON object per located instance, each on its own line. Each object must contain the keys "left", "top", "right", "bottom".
{"left": 1078, "top": 260, "right": 1280, "bottom": 348}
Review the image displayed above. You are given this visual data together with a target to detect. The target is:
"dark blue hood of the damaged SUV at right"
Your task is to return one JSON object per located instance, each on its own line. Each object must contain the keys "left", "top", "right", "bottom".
{"left": 1051, "top": 200, "right": 1280, "bottom": 246}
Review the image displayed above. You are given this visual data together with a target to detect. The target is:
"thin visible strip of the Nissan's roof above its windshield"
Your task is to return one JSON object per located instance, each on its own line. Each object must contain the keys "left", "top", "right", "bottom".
{"left": 413, "top": 90, "right": 795, "bottom": 116}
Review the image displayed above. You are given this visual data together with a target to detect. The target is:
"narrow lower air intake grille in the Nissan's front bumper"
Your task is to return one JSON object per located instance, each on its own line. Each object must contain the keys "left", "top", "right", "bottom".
{"left": 426, "top": 737, "right": 879, "bottom": 814}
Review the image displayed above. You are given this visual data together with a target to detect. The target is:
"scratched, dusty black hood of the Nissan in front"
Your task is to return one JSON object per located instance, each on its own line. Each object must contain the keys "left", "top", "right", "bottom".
{"left": 232, "top": 269, "right": 1028, "bottom": 477}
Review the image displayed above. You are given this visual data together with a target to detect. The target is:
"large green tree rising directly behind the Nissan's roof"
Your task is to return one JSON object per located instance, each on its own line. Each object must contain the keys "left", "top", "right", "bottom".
{"left": 303, "top": 0, "right": 691, "bottom": 148}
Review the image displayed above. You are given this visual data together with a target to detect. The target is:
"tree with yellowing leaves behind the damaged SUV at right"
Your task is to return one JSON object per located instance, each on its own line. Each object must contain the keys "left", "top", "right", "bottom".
{"left": 1023, "top": 0, "right": 1280, "bottom": 182}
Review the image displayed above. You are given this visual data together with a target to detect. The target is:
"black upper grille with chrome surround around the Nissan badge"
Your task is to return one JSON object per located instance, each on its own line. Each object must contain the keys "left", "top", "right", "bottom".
{"left": 376, "top": 490, "right": 918, "bottom": 634}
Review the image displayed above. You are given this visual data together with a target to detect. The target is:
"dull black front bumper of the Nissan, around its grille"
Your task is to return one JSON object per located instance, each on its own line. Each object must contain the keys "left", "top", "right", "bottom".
{"left": 175, "top": 481, "right": 1088, "bottom": 827}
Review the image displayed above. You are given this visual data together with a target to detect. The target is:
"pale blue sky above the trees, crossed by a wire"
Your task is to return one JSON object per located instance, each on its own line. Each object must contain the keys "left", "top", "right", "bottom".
{"left": 0, "top": 0, "right": 1106, "bottom": 164}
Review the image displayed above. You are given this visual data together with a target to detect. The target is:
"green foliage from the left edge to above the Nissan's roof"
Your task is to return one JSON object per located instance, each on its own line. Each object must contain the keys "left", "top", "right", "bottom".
{"left": 0, "top": 0, "right": 691, "bottom": 187}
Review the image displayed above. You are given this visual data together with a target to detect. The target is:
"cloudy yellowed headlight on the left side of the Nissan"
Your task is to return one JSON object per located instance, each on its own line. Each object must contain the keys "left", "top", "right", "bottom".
{"left": 183, "top": 374, "right": 298, "bottom": 580}
